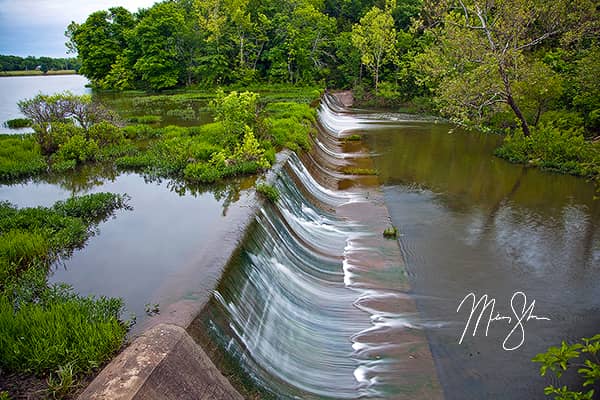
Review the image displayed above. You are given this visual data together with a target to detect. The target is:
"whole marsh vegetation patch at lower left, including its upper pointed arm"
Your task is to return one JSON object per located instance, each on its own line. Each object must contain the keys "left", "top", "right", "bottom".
{"left": 0, "top": 193, "right": 128, "bottom": 397}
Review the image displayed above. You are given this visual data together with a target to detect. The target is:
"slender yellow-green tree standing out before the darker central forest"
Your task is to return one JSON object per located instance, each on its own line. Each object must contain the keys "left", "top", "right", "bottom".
{"left": 352, "top": 0, "right": 397, "bottom": 94}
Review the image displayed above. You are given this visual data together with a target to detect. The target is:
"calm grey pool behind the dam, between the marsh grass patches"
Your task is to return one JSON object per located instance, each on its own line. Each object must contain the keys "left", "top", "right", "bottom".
{"left": 0, "top": 165, "right": 253, "bottom": 328}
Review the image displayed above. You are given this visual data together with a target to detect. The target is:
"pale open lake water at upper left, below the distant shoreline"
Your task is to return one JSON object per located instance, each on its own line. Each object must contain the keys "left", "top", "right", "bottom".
{"left": 0, "top": 75, "right": 91, "bottom": 133}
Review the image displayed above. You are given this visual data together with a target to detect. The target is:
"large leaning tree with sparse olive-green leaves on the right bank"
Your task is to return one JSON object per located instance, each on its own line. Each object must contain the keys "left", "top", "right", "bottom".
{"left": 417, "top": 0, "right": 595, "bottom": 136}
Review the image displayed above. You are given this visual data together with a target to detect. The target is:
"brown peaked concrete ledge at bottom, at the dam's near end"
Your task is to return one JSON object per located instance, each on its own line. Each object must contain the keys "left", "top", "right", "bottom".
{"left": 79, "top": 324, "right": 243, "bottom": 400}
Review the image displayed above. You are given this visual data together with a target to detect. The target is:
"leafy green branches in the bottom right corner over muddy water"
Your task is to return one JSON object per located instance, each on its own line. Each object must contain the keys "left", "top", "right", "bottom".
{"left": 532, "top": 334, "right": 600, "bottom": 400}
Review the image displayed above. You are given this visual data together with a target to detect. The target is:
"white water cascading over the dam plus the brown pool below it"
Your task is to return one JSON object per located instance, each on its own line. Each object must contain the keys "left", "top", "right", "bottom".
{"left": 192, "top": 97, "right": 600, "bottom": 399}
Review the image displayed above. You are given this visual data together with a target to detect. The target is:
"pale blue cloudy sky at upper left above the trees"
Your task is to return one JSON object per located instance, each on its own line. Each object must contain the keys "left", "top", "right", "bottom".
{"left": 0, "top": 0, "right": 157, "bottom": 57}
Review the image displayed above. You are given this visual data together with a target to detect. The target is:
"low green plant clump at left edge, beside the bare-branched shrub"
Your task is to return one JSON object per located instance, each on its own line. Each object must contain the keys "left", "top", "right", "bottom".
{"left": 0, "top": 135, "right": 46, "bottom": 182}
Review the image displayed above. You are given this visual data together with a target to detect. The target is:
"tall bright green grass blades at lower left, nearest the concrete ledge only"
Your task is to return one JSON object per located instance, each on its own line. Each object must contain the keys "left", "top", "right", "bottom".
{"left": 0, "top": 295, "right": 125, "bottom": 374}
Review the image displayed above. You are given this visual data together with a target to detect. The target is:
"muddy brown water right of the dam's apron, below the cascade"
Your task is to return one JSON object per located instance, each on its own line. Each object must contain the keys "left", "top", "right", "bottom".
{"left": 363, "top": 108, "right": 600, "bottom": 399}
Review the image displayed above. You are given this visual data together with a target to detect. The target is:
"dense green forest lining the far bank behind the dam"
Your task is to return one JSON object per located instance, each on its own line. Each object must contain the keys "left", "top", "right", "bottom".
{"left": 66, "top": 0, "right": 600, "bottom": 136}
